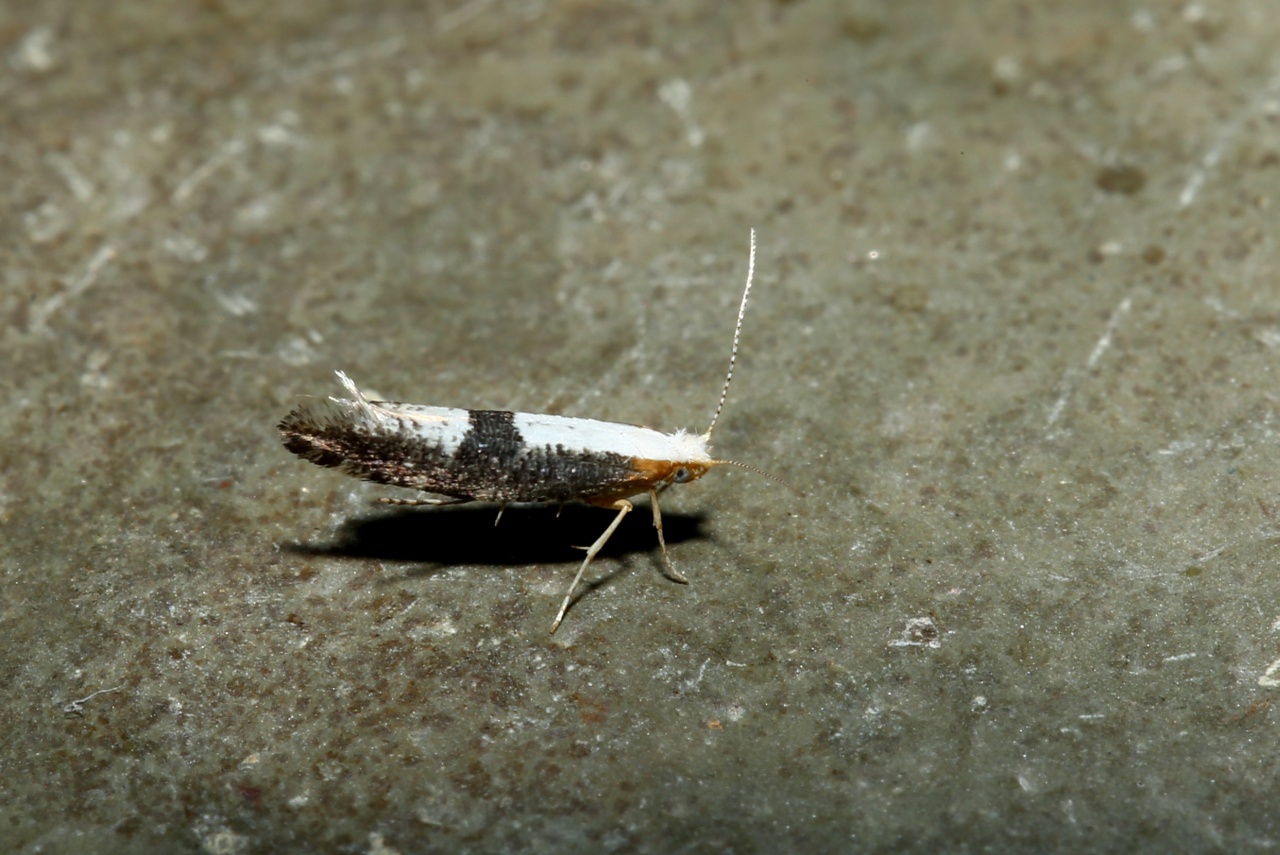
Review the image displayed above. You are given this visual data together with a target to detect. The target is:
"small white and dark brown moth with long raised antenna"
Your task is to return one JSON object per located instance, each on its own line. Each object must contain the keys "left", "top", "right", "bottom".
{"left": 279, "top": 229, "right": 772, "bottom": 632}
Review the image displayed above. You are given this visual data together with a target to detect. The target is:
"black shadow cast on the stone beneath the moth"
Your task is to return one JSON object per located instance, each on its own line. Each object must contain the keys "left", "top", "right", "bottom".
{"left": 284, "top": 504, "right": 707, "bottom": 567}
